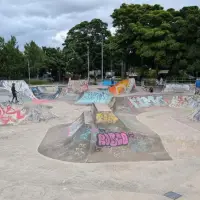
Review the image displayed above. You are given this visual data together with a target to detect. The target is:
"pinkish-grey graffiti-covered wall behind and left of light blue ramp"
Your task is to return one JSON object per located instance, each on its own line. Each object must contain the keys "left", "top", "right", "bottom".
{"left": 66, "top": 80, "right": 88, "bottom": 94}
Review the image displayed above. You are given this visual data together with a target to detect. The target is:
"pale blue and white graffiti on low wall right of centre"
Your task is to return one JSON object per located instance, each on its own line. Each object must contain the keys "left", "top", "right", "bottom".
{"left": 128, "top": 96, "right": 167, "bottom": 108}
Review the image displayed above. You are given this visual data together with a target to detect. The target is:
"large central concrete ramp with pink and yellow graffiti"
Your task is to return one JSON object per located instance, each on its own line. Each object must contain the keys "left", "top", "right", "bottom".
{"left": 38, "top": 101, "right": 171, "bottom": 163}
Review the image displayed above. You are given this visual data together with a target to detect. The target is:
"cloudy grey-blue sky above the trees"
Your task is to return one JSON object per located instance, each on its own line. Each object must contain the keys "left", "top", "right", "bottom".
{"left": 0, "top": 0, "right": 200, "bottom": 48}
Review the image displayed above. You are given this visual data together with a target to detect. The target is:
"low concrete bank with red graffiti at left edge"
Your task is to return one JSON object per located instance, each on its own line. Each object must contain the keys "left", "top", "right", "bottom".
{"left": 0, "top": 104, "right": 56, "bottom": 126}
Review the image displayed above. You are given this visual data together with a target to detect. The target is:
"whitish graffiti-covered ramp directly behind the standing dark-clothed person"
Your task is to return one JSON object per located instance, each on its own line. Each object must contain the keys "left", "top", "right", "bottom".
{"left": 1, "top": 80, "right": 36, "bottom": 99}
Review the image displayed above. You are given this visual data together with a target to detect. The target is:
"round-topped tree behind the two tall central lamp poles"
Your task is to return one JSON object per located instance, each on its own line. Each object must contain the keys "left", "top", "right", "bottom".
{"left": 63, "top": 19, "right": 110, "bottom": 74}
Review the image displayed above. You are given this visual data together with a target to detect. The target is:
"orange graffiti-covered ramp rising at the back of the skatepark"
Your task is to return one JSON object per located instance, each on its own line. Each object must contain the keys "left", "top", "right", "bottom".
{"left": 109, "top": 78, "right": 136, "bottom": 95}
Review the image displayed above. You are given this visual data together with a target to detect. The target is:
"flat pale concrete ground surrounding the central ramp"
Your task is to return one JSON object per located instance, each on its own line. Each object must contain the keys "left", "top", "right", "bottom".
{"left": 0, "top": 102, "right": 200, "bottom": 200}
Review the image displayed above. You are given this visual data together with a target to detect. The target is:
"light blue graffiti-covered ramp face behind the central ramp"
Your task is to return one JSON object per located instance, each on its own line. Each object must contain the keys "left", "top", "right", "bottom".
{"left": 76, "top": 91, "right": 112, "bottom": 104}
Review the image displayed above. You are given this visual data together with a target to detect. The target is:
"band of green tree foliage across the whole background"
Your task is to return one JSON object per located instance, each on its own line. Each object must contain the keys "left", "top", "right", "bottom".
{"left": 0, "top": 4, "right": 200, "bottom": 80}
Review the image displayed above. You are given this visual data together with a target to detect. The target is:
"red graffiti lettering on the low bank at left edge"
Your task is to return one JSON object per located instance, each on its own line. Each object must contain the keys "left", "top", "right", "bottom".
{"left": 0, "top": 106, "right": 25, "bottom": 125}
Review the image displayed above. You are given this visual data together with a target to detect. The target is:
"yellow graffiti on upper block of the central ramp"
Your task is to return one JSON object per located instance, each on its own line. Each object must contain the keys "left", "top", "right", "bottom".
{"left": 96, "top": 112, "right": 118, "bottom": 124}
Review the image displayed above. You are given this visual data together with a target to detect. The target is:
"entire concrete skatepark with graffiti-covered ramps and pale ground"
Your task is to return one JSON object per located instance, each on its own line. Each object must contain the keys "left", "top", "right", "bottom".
{"left": 0, "top": 80, "right": 200, "bottom": 200}
